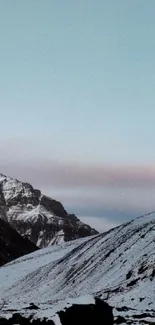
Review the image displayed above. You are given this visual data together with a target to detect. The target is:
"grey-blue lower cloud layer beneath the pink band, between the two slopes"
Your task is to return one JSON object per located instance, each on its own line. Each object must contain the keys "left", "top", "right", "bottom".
{"left": 43, "top": 187, "right": 155, "bottom": 223}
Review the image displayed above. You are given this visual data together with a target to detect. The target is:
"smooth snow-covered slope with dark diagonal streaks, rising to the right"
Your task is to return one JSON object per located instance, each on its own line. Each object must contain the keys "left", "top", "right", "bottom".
{"left": 0, "top": 212, "right": 155, "bottom": 324}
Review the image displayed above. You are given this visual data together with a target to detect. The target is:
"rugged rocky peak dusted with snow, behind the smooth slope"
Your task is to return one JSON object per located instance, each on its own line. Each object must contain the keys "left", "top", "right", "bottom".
{"left": 0, "top": 174, "right": 97, "bottom": 247}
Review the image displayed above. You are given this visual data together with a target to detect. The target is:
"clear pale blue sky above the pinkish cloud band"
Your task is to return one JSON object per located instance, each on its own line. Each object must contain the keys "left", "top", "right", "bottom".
{"left": 0, "top": 0, "right": 155, "bottom": 230}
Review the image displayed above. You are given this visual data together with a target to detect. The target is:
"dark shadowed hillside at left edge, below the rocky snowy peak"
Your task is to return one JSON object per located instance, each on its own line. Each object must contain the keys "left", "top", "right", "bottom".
{"left": 0, "top": 215, "right": 38, "bottom": 266}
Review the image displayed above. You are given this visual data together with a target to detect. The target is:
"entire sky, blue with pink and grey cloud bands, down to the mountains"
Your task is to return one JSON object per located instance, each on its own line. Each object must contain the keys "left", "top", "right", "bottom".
{"left": 0, "top": 0, "right": 155, "bottom": 231}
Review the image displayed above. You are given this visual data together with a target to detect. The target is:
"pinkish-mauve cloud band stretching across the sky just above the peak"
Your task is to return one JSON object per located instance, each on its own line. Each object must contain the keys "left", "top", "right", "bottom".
{"left": 0, "top": 158, "right": 155, "bottom": 188}
